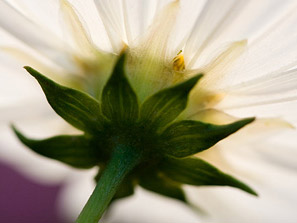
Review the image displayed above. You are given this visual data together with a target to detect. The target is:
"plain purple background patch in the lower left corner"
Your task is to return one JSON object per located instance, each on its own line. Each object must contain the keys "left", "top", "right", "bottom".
{"left": 0, "top": 162, "right": 66, "bottom": 223}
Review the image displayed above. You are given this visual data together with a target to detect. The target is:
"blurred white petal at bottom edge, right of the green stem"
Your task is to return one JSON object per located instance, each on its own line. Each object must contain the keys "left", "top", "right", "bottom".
{"left": 106, "top": 187, "right": 201, "bottom": 223}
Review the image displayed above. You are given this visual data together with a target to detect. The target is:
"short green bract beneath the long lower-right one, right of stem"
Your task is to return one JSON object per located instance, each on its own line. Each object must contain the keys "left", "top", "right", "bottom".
{"left": 139, "top": 172, "right": 187, "bottom": 202}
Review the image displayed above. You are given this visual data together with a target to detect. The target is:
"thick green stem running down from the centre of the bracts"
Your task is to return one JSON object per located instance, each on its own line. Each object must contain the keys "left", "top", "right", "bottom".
{"left": 76, "top": 145, "right": 141, "bottom": 223}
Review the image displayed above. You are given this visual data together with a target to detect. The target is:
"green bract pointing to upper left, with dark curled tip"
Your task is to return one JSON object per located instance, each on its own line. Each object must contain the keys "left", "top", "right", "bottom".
{"left": 25, "top": 67, "right": 102, "bottom": 132}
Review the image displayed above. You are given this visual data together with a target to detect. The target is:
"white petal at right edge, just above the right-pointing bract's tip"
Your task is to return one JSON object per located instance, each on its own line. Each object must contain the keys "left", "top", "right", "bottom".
{"left": 218, "top": 69, "right": 297, "bottom": 116}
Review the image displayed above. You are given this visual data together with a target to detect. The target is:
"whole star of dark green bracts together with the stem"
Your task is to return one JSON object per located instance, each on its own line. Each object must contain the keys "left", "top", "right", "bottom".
{"left": 14, "top": 54, "right": 256, "bottom": 223}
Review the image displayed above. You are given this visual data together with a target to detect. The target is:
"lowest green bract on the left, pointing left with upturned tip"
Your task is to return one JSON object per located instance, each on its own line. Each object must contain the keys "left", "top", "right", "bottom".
{"left": 13, "top": 127, "right": 98, "bottom": 168}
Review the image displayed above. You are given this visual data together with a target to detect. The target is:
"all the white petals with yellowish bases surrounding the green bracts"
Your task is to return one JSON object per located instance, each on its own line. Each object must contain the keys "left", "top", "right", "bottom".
{"left": 0, "top": 0, "right": 297, "bottom": 222}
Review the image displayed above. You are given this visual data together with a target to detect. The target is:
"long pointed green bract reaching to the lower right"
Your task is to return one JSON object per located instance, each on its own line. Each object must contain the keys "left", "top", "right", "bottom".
{"left": 160, "top": 158, "right": 257, "bottom": 196}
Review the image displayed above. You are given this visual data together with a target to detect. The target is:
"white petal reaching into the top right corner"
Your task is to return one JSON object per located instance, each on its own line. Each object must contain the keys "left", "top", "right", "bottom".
{"left": 191, "top": 0, "right": 296, "bottom": 58}
